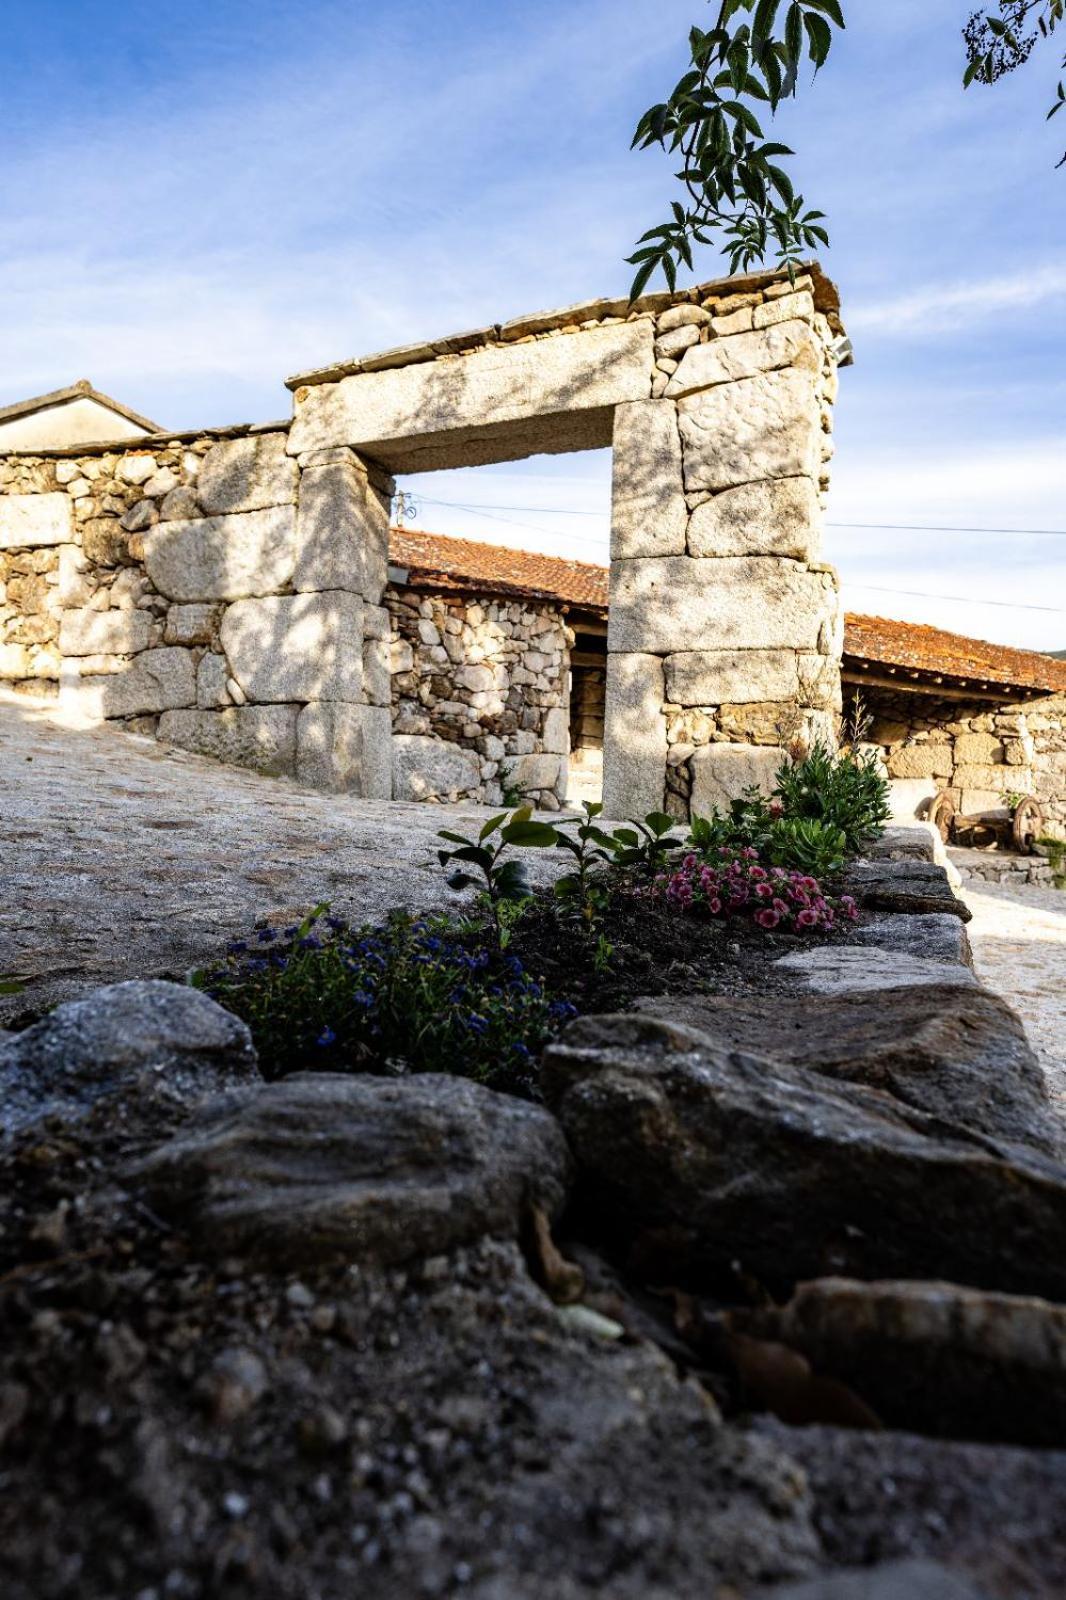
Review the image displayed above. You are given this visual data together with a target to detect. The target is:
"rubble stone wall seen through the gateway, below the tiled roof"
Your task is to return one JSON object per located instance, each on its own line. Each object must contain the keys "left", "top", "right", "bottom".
{"left": 386, "top": 587, "right": 573, "bottom": 811}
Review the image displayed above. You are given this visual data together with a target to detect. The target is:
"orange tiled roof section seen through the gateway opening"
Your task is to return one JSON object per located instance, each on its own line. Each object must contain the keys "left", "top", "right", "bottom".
{"left": 389, "top": 528, "right": 607, "bottom": 611}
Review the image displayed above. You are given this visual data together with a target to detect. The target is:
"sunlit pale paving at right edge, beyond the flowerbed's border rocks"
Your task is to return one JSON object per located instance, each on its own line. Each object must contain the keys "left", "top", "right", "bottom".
{"left": 960, "top": 883, "right": 1066, "bottom": 1114}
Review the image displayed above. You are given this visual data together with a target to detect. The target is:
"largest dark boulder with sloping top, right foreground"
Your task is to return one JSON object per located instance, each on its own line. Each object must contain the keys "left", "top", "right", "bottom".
{"left": 543, "top": 1006, "right": 1066, "bottom": 1299}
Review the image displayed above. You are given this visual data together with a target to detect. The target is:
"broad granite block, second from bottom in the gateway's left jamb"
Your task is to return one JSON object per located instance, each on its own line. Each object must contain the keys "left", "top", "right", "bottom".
{"left": 221, "top": 589, "right": 363, "bottom": 701}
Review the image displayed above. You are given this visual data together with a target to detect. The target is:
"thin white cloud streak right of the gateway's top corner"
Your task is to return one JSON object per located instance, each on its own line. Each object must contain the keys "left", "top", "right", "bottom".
{"left": 847, "top": 264, "right": 1066, "bottom": 336}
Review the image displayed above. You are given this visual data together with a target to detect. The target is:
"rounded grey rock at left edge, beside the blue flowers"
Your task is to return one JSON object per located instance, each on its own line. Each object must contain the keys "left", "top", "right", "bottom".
{"left": 0, "top": 981, "right": 259, "bottom": 1136}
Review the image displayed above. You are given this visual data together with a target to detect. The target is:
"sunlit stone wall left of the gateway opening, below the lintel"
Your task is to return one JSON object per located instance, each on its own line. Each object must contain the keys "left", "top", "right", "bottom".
{"left": 0, "top": 426, "right": 391, "bottom": 798}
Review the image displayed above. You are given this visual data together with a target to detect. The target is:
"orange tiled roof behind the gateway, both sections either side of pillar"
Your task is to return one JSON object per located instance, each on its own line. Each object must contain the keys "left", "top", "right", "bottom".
{"left": 389, "top": 528, "right": 1066, "bottom": 694}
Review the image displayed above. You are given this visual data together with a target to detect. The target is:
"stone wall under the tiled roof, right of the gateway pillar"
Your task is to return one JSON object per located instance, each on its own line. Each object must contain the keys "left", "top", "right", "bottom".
{"left": 848, "top": 688, "right": 1066, "bottom": 838}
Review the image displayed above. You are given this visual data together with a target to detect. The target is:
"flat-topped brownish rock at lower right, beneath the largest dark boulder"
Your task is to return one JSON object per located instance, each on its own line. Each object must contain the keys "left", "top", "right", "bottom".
{"left": 731, "top": 1278, "right": 1066, "bottom": 1448}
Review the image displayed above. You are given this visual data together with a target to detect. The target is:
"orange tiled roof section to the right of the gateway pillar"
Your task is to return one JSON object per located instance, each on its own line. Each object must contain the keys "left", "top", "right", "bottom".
{"left": 844, "top": 614, "right": 1066, "bottom": 694}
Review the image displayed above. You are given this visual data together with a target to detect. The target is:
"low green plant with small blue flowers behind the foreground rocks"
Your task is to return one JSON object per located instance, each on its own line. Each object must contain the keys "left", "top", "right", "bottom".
{"left": 190, "top": 906, "right": 575, "bottom": 1096}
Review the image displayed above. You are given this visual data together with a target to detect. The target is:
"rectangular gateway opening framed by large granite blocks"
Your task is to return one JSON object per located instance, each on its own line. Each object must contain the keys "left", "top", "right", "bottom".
{"left": 386, "top": 454, "right": 611, "bottom": 810}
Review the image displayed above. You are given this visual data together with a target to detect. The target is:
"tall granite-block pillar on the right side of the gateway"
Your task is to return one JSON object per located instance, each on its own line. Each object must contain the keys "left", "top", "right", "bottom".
{"left": 603, "top": 278, "right": 844, "bottom": 818}
